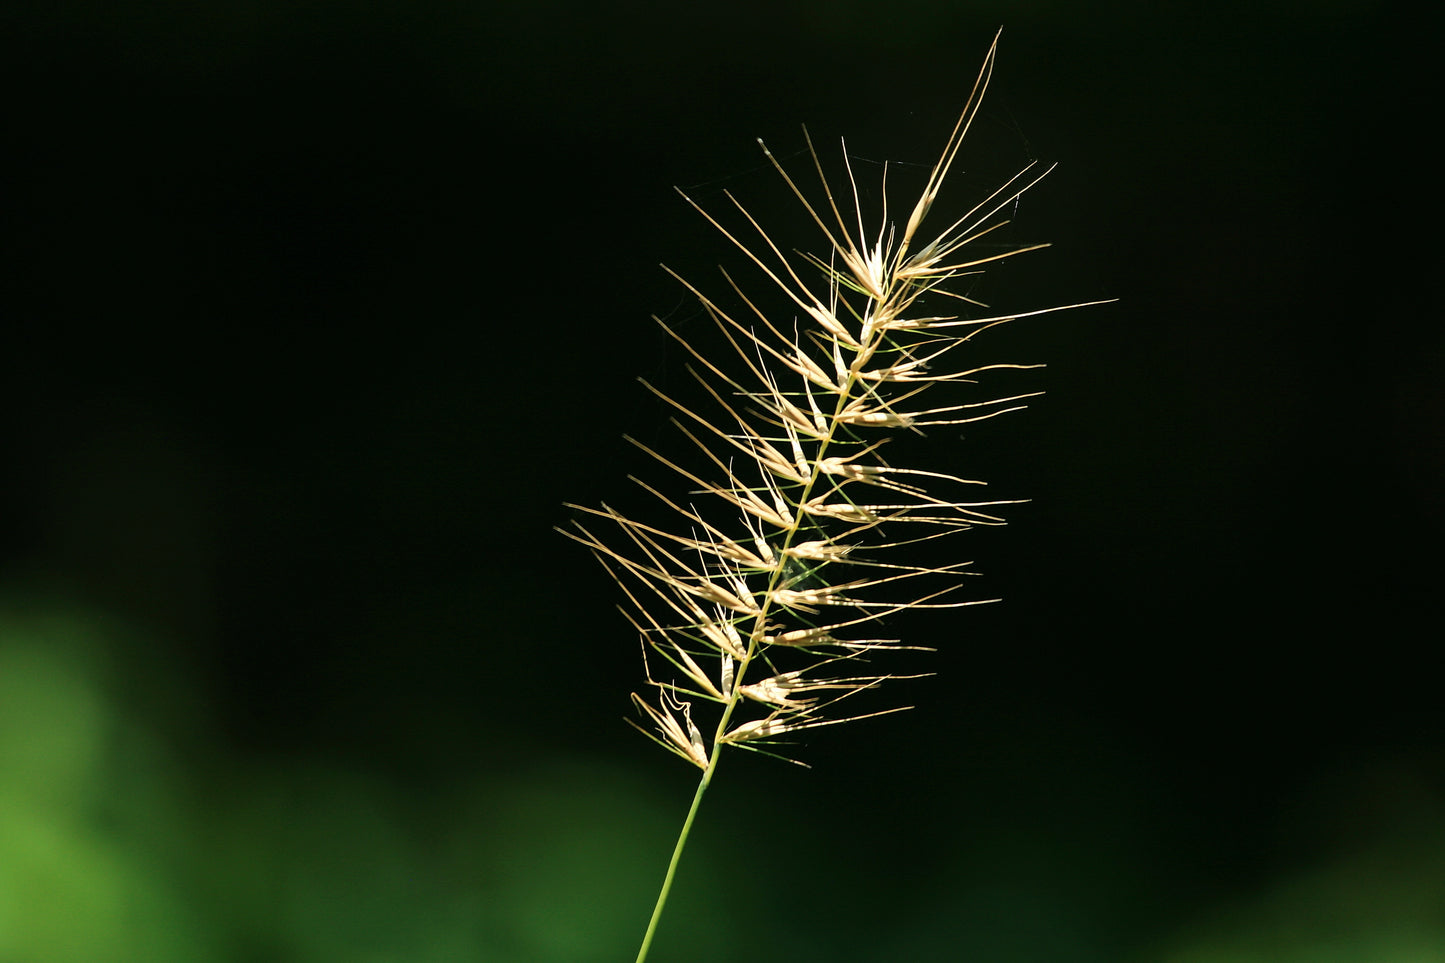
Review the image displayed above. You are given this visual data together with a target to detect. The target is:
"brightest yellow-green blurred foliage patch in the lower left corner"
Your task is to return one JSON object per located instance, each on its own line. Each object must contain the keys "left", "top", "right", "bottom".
{"left": 0, "top": 606, "right": 206, "bottom": 963}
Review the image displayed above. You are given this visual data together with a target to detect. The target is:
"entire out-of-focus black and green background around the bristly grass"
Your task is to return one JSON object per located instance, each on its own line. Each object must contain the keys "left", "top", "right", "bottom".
{"left": 0, "top": 0, "right": 1445, "bottom": 963}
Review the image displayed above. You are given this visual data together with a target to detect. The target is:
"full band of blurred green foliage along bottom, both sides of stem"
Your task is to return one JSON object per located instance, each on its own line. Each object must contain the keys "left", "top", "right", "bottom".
{"left": 0, "top": 595, "right": 1445, "bottom": 963}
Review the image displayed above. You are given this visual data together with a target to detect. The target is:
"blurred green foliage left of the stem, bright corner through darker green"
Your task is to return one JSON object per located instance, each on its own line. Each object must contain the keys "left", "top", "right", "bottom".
{"left": 0, "top": 595, "right": 728, "bottom": 963}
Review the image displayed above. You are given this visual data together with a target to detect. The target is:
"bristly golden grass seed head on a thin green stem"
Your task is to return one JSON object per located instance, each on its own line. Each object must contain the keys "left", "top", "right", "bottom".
{"left": 565, "top": 36, "right": 1098, "bottom": 963}
